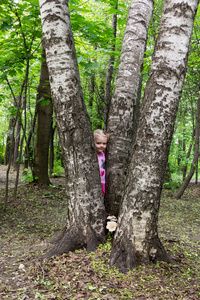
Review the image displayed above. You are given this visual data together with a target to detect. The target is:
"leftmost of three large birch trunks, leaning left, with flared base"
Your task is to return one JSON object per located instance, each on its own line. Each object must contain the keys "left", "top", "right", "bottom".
{"left": 40, "top": 0, "right": 105, "bottom": 256}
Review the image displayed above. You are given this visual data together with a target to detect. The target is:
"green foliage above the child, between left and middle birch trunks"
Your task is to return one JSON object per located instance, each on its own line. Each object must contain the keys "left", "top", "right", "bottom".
{"left": 69, "top": 1, "right": 128, "bottom": 129}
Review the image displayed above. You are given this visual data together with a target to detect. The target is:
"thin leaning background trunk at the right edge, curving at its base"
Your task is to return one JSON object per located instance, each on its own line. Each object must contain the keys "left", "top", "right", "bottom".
{"left": 174, "top": 92, "right": 200, "bottom": 199}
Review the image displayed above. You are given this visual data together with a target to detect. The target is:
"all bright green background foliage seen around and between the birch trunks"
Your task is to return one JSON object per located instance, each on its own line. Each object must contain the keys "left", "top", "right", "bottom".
{"left": 0, "top": 0, "right": 200, "bottom": 186}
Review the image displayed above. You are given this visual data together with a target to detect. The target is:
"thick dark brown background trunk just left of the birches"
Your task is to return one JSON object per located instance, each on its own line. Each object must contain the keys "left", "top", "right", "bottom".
{"left": 33, "top": 50, "right": 53, "bottom": 185}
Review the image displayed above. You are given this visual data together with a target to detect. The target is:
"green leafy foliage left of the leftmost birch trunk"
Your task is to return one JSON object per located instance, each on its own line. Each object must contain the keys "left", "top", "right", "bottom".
{"left": 0, "top": 0, "right": 41, "bottom": 169}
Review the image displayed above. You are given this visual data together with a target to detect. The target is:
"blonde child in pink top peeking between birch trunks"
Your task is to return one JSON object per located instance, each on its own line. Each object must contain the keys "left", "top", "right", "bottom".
{"left": 94, "top": 129, "right": 110, "bottom": 196}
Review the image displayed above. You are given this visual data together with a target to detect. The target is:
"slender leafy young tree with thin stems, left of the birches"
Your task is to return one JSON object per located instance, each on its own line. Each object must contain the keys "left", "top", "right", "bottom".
{"left": 0, "top": 1, "right": 41, "bottom": 209}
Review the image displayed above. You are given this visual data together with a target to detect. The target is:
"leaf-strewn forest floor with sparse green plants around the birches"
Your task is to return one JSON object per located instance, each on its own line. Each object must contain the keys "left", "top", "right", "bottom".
{"left": 0, "top": 166, "right": 200, "bottom": 300}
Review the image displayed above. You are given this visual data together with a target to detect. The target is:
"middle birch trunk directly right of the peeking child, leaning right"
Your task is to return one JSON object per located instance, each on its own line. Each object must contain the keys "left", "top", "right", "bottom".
{"left": 105, "top": 0, "right": 153, "bottom": 216}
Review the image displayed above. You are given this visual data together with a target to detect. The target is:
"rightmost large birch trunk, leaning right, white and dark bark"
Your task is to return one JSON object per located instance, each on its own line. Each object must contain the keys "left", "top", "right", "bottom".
{"left": 111, "top": 0, "right": 198, "bottom": 270}
